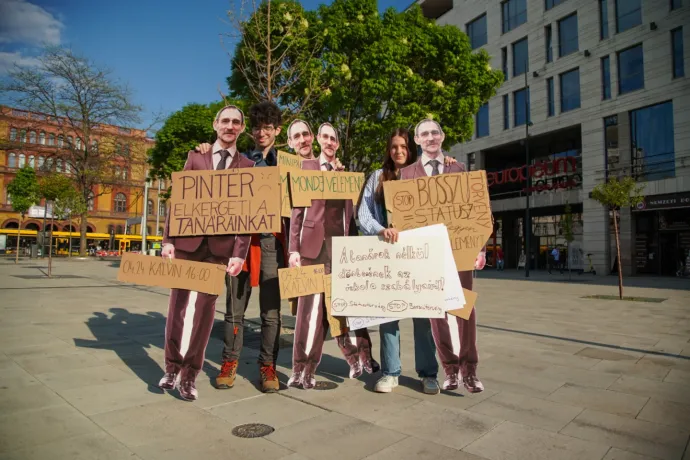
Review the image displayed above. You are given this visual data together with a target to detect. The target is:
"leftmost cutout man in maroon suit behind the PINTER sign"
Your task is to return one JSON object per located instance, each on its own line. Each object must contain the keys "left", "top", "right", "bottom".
{"left": 158, "top": 106, "right": 254, "bottom": 401}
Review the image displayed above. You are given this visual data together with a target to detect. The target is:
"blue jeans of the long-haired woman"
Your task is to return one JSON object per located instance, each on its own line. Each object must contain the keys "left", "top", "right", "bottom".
{"left": 379, "top": 318, "right": 438, "bottom": 378}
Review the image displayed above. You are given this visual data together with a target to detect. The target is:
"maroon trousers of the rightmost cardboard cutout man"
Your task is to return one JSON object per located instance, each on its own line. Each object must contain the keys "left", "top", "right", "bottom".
{"left": 431, "top": 271, "right": 479, "bottom": 376}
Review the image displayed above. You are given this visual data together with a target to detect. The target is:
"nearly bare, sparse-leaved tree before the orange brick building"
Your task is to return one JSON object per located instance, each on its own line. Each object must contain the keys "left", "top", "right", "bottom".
{"left": 0, "top": 47, "right": 145, "bottom": 256}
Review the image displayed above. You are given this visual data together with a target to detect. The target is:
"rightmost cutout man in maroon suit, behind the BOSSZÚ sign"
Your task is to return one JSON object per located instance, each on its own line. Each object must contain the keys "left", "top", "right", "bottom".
{"left": 400, "top": 119, "right": 486, "bottom": 393}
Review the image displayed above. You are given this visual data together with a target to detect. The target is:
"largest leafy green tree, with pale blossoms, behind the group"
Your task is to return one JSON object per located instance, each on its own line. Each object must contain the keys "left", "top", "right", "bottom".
{"left": 230, "top": 0, "right": 503, "bottom": 171}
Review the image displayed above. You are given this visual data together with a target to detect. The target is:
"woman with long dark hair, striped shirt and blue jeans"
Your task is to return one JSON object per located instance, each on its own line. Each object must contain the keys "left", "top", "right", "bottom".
{"left": 358, "top": 128, "right": 456, "bottom": 394}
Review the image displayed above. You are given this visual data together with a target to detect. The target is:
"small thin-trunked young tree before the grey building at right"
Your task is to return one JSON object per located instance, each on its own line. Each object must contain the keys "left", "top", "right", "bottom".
{"left": 592, "top": 176, "right": 644, "bottom": 300}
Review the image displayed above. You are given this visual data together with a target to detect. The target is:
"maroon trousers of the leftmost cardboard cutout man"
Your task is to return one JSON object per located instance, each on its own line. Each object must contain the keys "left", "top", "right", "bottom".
{"left": 165, "top": 238, "right": 228, "bottom": 381}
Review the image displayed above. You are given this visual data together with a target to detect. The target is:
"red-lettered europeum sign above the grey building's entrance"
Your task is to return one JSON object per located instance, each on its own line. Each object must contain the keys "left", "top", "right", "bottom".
{"left": 486, "top": 156, "right": 582, "bottom": 193}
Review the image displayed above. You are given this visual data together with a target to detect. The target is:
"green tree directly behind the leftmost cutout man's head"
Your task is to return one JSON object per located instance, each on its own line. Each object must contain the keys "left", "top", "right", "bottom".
{"left": 148, "top": 100, "right": 253, "bottom": 189}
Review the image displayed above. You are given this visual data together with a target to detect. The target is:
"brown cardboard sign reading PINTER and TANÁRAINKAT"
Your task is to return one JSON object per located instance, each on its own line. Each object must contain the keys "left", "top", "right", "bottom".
{"left": 170, "top": 167, "right": 281, "bottom": 236}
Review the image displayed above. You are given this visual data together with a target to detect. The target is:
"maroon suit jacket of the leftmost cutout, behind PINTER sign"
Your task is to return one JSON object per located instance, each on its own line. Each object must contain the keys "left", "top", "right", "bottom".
{"left": 163, "top": 150, "right": 254, "bottom": 260}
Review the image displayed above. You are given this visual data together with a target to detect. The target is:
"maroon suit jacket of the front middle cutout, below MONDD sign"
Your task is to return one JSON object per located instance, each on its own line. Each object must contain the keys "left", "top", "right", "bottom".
{"left": 290, "top": 159, "right": 357, "bottom": 259}
